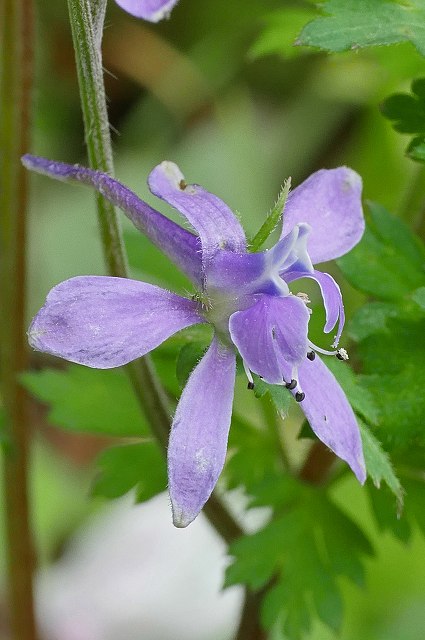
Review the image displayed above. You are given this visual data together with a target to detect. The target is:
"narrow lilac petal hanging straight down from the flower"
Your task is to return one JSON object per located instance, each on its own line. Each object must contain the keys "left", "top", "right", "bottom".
{"left": 168, "top": 338, "right": 236, "bottom": 527}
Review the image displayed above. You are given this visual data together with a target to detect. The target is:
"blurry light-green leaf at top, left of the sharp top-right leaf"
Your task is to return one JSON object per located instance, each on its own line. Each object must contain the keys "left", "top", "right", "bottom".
{"left": 249, "top": 7, "right": 317, "bottom": 58}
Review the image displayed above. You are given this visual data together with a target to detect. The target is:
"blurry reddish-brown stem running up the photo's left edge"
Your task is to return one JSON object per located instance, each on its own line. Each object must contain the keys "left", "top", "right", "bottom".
{"left": 0, "top": 0, "right": 36, "bottom": 640}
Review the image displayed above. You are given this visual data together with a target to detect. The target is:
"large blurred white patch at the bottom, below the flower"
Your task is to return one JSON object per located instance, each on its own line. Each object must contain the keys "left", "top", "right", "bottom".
{"left": 37, "top": 494, "right": 243, "bottom": 640}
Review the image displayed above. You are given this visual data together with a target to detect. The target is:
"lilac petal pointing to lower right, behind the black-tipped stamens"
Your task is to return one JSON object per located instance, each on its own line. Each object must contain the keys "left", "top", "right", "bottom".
{"left": 298, "top": 356, "right": 366, "bottom": 484}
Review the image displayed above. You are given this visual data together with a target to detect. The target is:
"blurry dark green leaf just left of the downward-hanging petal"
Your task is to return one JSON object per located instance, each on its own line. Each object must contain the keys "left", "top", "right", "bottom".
{"left": 92, "top": 442, "right": 167, "bottom": 502}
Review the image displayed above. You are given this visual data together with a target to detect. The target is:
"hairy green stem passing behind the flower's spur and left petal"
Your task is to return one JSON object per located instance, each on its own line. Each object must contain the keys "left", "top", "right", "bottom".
{"left": 68, "top": 0, "right": 238, "bottom": 542}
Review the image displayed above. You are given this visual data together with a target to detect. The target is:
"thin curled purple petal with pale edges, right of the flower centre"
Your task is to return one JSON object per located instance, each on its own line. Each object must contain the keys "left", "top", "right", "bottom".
{"left": 282, "top": 270, "right": 345, "bottom": 347}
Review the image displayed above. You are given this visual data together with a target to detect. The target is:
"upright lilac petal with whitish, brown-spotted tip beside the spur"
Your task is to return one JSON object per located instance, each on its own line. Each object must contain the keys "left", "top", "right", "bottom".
{"left": 148, "top": 162, "right": 246, "bottom": 263}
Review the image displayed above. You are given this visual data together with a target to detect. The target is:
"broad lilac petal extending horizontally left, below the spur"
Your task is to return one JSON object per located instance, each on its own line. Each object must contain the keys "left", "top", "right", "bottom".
{"left": 28, "top": 276, "right": 203, "bottom": 369}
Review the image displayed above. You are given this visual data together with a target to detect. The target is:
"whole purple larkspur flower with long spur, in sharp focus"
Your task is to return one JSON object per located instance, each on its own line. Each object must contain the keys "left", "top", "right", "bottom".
{"left": 23, "top": 156, "right": 366, "bottom": 527}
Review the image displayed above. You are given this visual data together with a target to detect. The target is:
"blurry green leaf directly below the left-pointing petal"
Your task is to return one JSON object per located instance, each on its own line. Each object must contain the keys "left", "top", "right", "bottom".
{"left": 21, "top": 365, "right": 148, "bottom": 436}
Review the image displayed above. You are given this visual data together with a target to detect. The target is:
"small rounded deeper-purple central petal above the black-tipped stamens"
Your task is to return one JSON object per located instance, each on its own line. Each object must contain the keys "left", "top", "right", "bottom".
{"left": 229, "top": 294, "right": 310, "bottom": 384}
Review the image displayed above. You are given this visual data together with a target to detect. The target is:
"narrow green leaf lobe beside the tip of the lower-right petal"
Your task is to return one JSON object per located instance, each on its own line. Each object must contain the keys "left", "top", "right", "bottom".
{"left": 359, "top": 420, "right": 404, "bottom": 514}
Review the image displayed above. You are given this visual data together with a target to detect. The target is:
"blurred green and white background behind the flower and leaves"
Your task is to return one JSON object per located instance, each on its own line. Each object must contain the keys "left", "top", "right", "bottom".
{"left": 0, "top": 0, "right": 425, "bottom": 640}
